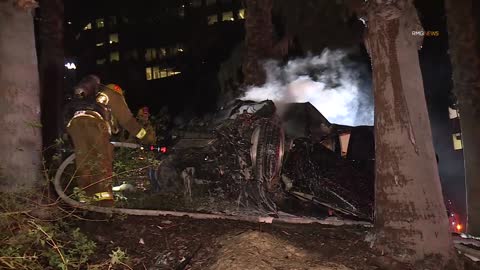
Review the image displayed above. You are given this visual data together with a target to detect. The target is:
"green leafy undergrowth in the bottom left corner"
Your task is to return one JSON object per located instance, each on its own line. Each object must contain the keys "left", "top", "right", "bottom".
{"left": 0, "top": 194, "right": 96, "bottom": 269}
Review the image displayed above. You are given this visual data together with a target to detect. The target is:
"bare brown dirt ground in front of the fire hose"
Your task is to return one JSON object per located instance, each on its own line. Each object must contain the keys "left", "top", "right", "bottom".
{"left": 75, "top": 217, "right": 392, "bottom": 270}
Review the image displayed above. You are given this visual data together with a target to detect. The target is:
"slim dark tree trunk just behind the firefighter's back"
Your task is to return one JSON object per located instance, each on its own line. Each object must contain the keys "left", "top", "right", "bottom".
{"left": 39, "top": 0, "right": 65, "bottom": 159}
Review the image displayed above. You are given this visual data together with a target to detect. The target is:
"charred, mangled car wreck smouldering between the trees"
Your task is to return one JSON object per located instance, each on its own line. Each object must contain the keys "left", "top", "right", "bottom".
{"left": 149, "top": 100, "right": 374, "bottom": 220}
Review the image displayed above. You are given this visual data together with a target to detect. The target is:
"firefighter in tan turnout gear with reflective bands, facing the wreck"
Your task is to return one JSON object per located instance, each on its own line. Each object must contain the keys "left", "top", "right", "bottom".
{"left": 67, "top": 75, "right": 154, "bottom": 207}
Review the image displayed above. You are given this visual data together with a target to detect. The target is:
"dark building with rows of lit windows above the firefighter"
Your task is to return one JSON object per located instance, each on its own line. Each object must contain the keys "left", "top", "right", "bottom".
{"left": 65, "top": 0, "right": 245, "bottom": 113}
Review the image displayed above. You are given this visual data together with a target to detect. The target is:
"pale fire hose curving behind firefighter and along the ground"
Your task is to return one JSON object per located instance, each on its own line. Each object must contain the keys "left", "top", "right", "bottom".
{"left": 54, "top": 142, "right": 371, "bottom": 227}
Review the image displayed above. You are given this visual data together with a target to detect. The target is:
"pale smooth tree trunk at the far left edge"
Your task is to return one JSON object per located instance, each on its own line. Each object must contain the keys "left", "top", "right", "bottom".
{"left": 0, "top": 0, "right": 42, "bottom": 191}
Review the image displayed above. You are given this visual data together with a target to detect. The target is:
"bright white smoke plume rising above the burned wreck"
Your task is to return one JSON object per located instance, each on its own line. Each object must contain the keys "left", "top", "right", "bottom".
{"left": 242, "top": 49, "right": 373, "bottom": 126}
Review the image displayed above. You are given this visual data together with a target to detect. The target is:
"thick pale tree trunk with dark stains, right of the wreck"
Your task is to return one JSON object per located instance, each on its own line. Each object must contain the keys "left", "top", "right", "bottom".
{"left": 366, "top": 0, "right": 454, "bottom": 269}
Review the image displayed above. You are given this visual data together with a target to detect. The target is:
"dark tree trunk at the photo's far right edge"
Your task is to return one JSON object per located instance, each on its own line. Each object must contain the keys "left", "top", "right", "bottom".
{"left": 445, "top": 0, "right": 480, "bottom": 236}
